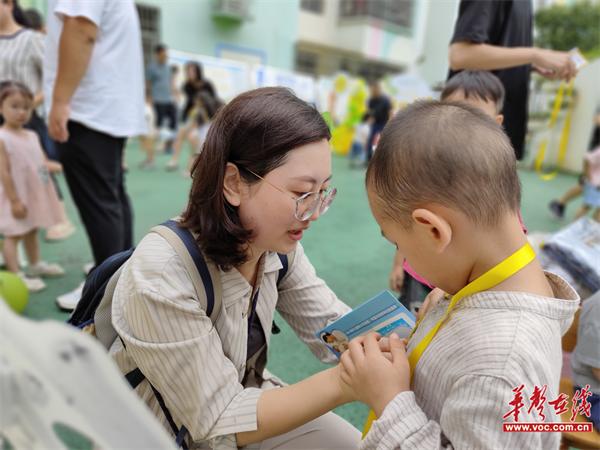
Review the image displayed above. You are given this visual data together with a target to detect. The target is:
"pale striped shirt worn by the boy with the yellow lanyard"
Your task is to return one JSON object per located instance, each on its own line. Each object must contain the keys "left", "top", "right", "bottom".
{"left": 361, "top": 273, "right": 579, "bottom": 450}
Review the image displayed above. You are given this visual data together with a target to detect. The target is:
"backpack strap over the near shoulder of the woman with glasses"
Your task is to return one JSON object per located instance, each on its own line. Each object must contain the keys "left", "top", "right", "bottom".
{"left": 150, "top": 220, "right": 223, "bottom": 324}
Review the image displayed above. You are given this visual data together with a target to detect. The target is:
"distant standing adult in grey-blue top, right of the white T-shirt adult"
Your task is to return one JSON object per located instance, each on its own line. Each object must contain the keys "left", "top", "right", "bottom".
{"left": 146, "top": 44, "right": 177, "bottom": 153}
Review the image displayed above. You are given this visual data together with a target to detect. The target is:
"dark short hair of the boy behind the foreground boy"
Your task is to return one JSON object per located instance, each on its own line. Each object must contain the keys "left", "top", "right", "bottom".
{"left": 440, "top": 70, "right": 504, "bottom": 114}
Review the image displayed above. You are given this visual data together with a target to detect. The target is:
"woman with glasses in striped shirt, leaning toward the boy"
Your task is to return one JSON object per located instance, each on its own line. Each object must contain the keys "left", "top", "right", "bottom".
{"left": 111, "top": 88, "right": 360, "bottom": 450}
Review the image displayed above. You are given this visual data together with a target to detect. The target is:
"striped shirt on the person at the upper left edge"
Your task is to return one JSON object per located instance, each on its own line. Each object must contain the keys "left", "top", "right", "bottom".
{"left": 0, "top": 28, "right": 44, "bottom": 95}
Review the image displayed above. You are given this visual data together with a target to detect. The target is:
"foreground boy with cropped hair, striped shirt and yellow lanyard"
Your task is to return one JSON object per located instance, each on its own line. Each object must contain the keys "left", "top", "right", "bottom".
{"left": 340, "top": 102, "right": 579, "bottom": 449}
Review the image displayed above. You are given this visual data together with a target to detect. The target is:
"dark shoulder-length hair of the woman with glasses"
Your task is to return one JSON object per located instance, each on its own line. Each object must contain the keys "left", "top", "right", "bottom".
{"left": 182, "top": 87, "right": 331, "bottom": 270}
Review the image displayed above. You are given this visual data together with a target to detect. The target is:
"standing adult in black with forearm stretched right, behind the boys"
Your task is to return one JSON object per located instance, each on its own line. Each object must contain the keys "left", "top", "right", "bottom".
{"left": 448, "top": 0, "right": 576, "bottom": 159}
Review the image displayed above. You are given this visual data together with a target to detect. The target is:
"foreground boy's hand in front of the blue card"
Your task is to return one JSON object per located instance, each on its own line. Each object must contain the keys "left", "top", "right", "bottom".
{"left": 340, "top": 333, "right": 410, "bottom": 416}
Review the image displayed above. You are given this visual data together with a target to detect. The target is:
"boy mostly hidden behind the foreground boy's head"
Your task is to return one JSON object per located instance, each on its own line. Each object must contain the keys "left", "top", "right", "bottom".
{"left": 389, "top": 70, "right": 504, "bottom": 313}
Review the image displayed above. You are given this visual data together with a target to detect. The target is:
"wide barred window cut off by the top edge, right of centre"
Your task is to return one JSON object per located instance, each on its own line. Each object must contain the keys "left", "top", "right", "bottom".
{"left": 340, "top": 0, "right": 413, "bottom": 28}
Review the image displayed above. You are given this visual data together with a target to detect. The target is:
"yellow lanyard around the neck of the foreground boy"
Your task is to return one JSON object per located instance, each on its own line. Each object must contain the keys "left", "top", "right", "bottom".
{"left": 363, "top": 243, "right": 535, "bottom": 437}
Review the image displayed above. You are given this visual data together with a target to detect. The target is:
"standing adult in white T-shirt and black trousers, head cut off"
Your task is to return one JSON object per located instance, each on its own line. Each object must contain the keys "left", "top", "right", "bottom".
{"left": 44, "top": 0, "right": 146, "bottom": 309}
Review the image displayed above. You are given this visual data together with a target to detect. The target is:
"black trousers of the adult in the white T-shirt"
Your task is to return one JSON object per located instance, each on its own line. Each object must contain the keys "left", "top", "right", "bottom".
{"left": 57, "top": 121, "right": 133, "bottom": 265}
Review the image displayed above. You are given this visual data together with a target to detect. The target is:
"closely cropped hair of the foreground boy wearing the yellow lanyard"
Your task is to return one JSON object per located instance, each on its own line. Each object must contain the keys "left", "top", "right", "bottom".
{"left": 366, "top": 101, "right": 521, "bottom": 228}
